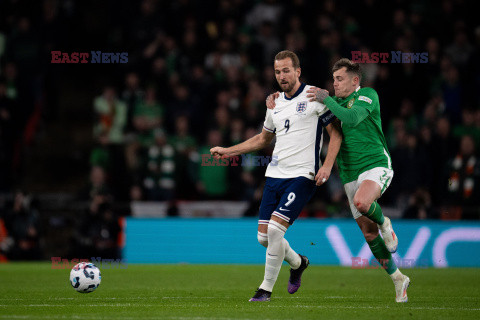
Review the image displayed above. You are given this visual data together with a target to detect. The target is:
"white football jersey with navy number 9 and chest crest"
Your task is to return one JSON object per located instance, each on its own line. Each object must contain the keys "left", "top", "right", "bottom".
{"left": 263, "top": 83, "right": 335, "bottom": 180}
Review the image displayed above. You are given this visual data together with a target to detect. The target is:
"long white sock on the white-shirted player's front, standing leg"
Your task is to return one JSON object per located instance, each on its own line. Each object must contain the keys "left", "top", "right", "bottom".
{"left": 260, "top": 220, "right": 287, "bottom": 292}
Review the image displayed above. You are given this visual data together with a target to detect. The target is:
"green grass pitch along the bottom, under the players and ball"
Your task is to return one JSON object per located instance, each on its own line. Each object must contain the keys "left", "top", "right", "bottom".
{"left": 0, "top": 263, "right": 480, "bottom": 320}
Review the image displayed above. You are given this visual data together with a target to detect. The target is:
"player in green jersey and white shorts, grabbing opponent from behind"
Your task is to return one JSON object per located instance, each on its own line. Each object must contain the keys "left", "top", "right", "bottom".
{"left": 267, "top": 58, "right": 410, "bottom": 302}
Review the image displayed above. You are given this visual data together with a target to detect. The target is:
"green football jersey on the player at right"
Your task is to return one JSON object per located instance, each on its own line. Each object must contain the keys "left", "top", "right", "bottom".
{"left": 324, "top": 87, "right": 392, "bottom": 184}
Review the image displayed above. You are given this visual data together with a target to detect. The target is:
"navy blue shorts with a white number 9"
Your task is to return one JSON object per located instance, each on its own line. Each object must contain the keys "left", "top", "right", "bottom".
{"left": 258, "top": 177, "right": 316, "bottom": 224}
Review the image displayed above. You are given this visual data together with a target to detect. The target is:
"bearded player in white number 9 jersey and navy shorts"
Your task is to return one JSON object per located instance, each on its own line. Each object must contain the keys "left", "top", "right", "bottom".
{"left": 210, "top": 51, "right": 342, "bottom": 301}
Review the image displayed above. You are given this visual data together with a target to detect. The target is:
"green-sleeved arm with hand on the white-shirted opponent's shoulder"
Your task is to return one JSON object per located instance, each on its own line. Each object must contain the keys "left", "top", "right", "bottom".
{"left": 307, "top": 87, "right": 369, "bottom": 126}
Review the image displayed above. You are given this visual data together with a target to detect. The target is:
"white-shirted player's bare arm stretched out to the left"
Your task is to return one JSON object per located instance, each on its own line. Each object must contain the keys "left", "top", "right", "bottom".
{"left": 210, "top": 129, "right": 275, "bottom": 159}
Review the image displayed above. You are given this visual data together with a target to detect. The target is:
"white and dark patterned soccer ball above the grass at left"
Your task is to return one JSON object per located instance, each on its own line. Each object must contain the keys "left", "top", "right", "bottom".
{"left": 70, "top": 262, "right": 102, "bottom": 293}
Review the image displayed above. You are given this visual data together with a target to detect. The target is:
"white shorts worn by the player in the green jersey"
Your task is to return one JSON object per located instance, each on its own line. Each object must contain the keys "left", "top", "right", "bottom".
{"left": 344, "top": 167, "right": 393, "bottom": 219}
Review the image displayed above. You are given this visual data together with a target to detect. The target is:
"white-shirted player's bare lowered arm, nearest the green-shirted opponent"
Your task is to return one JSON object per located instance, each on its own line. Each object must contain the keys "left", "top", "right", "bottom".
{"left": 315, "top": 120, "right": 343, "bottom": 186}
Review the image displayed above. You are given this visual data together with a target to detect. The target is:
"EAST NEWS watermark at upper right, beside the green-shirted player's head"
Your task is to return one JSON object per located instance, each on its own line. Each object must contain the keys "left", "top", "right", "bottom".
{"left": 351, "top": 51, "right": 428, "bottom": 63}
